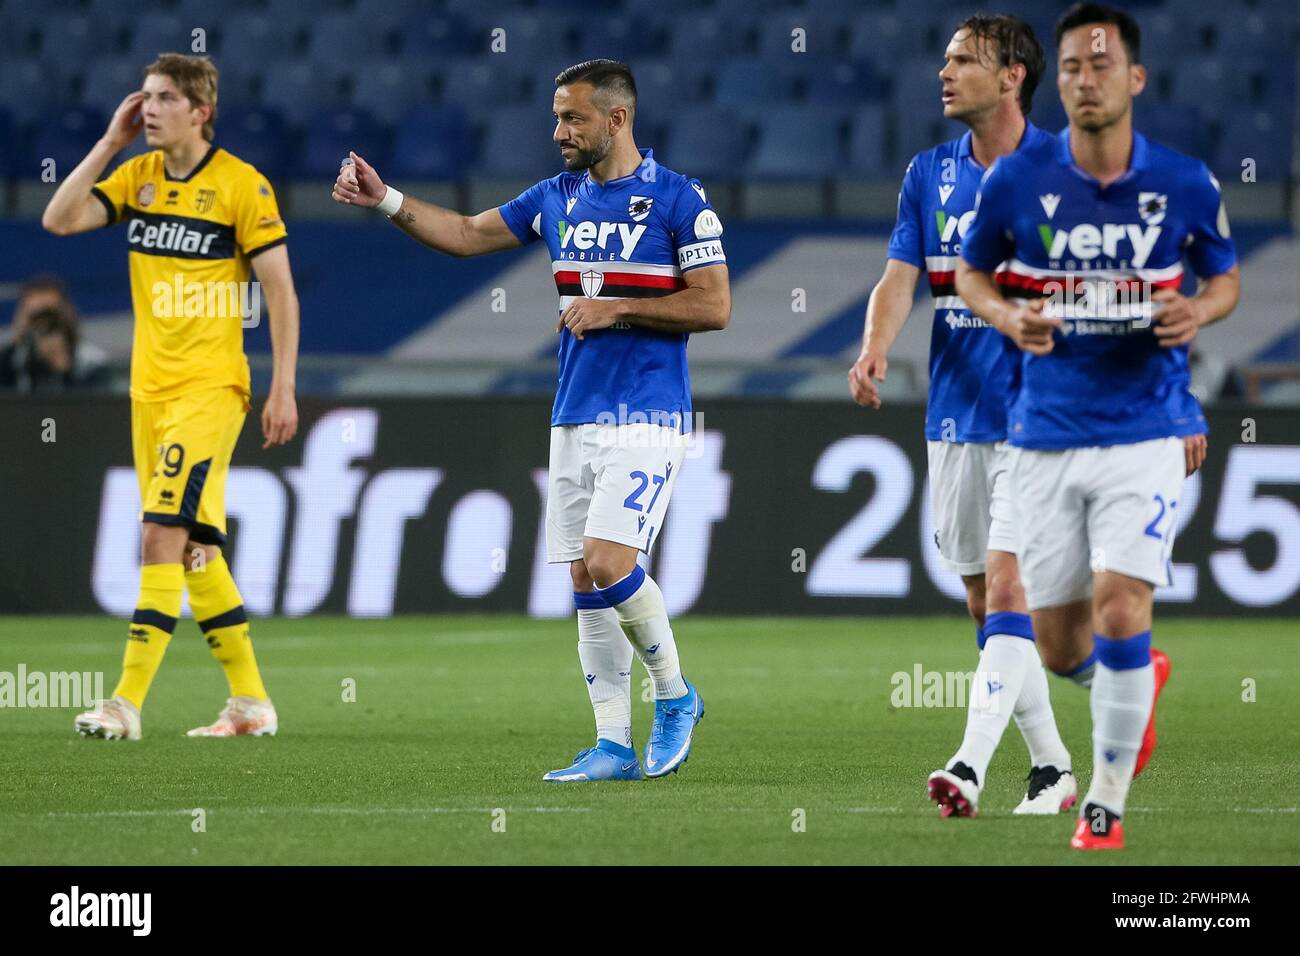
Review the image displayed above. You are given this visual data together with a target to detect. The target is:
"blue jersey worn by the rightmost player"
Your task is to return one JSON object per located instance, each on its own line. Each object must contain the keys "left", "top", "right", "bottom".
{"left": 962, "top": 130, "right": 1236, "bottom": 449}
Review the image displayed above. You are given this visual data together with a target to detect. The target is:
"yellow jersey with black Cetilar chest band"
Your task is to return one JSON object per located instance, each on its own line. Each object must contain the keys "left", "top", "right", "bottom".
{"left": 91, "top": 146, "right": 285, "bottom": 402}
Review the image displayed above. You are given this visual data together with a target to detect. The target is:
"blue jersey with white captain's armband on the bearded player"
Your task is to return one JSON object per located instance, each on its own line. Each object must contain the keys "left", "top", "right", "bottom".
{"left": 501, "top": 150, "right": 727, "bottom": 431}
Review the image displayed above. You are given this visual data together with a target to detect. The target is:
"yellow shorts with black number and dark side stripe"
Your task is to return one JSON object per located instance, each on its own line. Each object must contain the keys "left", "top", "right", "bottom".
{"left": 131, "top": 388, "right": 248, "bottom": 545}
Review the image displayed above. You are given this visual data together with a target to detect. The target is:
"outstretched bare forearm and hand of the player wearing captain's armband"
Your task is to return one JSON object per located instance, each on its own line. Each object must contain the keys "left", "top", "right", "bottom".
{"left": 333, "top": 152, "right": 520, "bottom": 256}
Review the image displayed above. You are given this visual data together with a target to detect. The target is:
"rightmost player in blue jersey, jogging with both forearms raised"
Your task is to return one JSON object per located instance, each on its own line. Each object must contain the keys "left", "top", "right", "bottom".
{"left": 957, "top": 4, "right": 1240, "bottom": 849}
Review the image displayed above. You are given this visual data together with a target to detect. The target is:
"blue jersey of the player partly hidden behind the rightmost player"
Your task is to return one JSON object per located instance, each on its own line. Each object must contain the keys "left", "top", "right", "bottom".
{"left": 889, "top": 124, "right": 1052, "bottom": 441}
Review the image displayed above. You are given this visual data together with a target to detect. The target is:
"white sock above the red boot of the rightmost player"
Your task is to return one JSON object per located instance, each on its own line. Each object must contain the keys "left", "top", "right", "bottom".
{"left": 1084, "top": 658, "right": 1156, "bottom": 817}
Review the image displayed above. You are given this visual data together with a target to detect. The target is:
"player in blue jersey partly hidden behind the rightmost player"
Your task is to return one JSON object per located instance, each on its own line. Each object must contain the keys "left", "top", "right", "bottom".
{"left": 849, "top": 16, "right": 1076, "bottom": 817}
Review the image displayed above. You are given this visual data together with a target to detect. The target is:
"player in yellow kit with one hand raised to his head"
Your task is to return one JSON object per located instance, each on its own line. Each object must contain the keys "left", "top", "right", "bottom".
{"left": 42, "top": 53, "right": 298, "bottom": 739}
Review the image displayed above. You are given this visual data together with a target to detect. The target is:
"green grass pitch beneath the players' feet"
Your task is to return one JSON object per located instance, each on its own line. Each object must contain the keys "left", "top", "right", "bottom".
{"left": 0, "top": 617, "right": 1300, "bottom": 865}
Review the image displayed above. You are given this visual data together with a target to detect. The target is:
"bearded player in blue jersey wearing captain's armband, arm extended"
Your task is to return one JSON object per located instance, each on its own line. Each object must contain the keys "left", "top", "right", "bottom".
{"left": 334, "top": 60, "right": 731, "bottom": 782}
